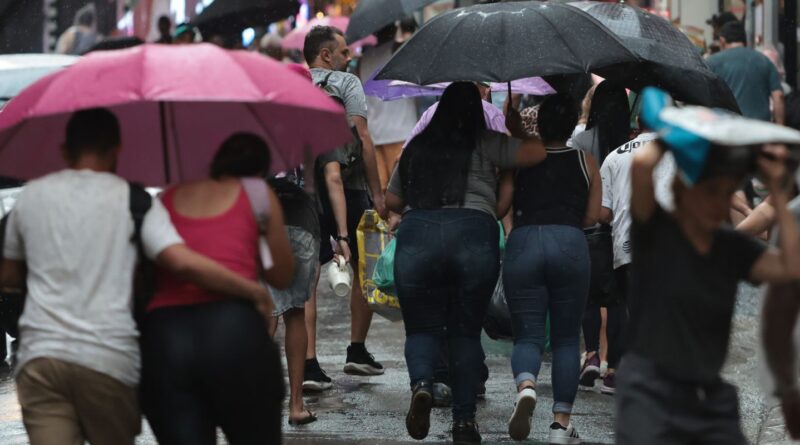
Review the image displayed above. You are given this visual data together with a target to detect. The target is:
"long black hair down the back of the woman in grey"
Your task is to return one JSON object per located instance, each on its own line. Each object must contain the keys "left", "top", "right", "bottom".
{"left": 399, "top": 82, "right": 486, "bottom": 209}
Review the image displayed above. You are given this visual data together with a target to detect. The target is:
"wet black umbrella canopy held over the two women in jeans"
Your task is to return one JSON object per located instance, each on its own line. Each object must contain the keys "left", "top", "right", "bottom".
{"left": 376, "top": 1, "right": 639, "bottom": 85}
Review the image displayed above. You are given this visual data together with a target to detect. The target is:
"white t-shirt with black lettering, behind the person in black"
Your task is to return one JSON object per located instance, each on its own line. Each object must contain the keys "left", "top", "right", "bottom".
{"left": 600, "top": 133, "right": 675, "bottom": 269}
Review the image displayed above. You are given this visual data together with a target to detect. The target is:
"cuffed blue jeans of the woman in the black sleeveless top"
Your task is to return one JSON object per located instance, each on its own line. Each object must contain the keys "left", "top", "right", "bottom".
{"left": 503, "top": 225, "right": 590, "bottom": 414}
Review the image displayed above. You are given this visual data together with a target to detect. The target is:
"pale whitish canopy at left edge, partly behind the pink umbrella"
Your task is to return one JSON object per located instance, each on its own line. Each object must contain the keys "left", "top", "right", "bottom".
{"left": 0, "top": 54, "right": 78, "bottom": 103}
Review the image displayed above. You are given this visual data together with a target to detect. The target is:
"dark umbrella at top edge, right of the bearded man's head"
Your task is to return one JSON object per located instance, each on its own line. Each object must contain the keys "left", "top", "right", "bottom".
{"left": 345, "top": 0, "right": 436, "bottom": 43}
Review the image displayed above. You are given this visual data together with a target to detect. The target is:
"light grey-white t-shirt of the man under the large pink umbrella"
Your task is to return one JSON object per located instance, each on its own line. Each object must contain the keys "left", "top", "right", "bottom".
{"left": 4, "top": 170, "right": 183, "bottom": 386}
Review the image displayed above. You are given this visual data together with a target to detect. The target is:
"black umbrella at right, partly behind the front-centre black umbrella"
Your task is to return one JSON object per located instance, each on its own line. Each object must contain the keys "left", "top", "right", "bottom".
{"left": 570, "top": 1, "right": 739, "bottom": 111}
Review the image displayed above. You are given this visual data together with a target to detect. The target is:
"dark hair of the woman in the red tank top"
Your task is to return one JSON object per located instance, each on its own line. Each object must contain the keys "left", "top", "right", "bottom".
{"left": 210, "top": 133, "right": 272, "bottom": 179}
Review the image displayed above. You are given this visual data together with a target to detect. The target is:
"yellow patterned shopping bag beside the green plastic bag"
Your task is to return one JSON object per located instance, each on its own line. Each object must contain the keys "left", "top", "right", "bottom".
{"left": 356, "top": 210, "right": 403, "bottom": 321}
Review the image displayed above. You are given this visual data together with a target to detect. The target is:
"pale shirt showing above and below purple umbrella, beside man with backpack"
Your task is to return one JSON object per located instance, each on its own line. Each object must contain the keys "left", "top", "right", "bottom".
{"left": 359, "top": 42, "right": 417, "bottom": 145}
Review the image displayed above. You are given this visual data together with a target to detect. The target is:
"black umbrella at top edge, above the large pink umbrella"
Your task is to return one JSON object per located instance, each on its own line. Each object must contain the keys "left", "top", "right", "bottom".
{"left": 193, "top": 0, "right": 300, "bottom": 38}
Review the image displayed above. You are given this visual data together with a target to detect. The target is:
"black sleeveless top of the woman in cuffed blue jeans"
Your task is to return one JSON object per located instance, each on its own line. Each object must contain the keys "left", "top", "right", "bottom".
{"left": 514, "top": 147, "right": 589, "bottom": 229}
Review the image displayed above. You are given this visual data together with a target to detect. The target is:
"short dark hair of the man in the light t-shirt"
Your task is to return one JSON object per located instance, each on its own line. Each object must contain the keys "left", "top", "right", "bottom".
{"left": 64, "top": 108, "right": 121, "bottom": 161}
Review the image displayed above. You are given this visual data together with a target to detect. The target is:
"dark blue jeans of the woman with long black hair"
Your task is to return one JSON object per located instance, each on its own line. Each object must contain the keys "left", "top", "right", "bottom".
{"left": 394, "top": 209, "right": 500, "bottom": 421}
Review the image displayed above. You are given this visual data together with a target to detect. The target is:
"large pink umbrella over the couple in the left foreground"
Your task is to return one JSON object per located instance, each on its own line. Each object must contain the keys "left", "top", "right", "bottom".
{"left": 0, "top": 44, "right": 351, "bottom": 186}
